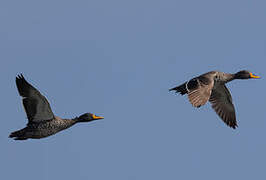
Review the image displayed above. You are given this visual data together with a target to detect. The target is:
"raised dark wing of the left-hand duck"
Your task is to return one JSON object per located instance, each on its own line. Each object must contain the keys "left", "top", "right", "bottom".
{"left": 16, "top": 74, "right": 54, "bottom": 123}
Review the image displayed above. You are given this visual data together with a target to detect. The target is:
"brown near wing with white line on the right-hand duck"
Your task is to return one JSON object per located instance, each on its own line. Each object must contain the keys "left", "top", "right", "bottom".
{"left": 185, "top": 76, "right": 214, "bottom": 107}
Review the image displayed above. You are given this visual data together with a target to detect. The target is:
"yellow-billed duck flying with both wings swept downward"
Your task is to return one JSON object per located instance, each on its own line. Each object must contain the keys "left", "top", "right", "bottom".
{"left": 169, "top": 70, "right": 260, "bottom": 129}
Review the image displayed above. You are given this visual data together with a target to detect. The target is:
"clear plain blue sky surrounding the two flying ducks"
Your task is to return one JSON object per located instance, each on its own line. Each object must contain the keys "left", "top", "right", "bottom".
{"left": 0, "top": 0, "right": 266, "bottom": 180}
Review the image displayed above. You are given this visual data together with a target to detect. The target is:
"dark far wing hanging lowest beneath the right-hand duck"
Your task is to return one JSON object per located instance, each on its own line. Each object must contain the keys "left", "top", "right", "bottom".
{"left": 209, "top": 84, "right": 237, "bottom": 129}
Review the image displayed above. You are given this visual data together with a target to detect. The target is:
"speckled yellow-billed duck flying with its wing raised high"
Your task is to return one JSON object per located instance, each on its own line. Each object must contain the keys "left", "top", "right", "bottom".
{"left": 9, "top": 74, "right": 103, "bottom": 140}
